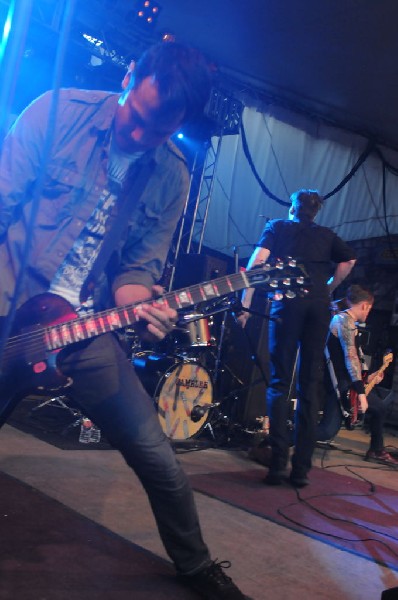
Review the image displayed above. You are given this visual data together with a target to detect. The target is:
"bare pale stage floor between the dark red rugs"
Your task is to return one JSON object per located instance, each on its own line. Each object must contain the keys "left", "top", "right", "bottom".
{"left": 0, "top": 418, "right": 398, "bottom": 600}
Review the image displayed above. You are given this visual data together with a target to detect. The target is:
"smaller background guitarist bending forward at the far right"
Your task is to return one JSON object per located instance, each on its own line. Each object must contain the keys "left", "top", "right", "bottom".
{"left": 317, "top": 285, "right": 398, "bottom": 465}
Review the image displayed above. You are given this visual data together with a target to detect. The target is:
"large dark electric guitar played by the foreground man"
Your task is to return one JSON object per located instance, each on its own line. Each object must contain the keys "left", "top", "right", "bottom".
{"left": 0, "top": 259, "right": 310, "bottom": 427}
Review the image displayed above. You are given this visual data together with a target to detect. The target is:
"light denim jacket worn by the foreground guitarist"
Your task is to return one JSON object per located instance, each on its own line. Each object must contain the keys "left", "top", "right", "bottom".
{"left": 0, "top": 89, "right": 189, "bottom": 315}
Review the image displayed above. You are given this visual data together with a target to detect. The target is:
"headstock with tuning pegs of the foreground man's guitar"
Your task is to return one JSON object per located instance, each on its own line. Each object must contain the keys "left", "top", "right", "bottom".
{"left": 246, "top": 257, "right": 311, "bottom": 300}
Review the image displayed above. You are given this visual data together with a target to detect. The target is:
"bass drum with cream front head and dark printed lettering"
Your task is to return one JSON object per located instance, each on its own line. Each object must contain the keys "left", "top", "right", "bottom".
{"left": 133, "top": 352, "right": 213, "bottom": 441}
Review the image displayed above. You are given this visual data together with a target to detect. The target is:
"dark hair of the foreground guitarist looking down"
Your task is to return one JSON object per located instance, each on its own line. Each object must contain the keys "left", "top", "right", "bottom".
{"left": 129, "top": 42, "right": 211, "bottom": 122}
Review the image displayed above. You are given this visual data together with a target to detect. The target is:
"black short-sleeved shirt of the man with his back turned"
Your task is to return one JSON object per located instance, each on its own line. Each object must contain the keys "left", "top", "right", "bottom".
{"left": 257, "top": 219, "right": 355, "bottom": 296}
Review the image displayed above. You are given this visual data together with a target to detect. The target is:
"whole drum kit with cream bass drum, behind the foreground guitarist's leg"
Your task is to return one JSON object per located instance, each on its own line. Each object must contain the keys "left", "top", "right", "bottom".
{"left": 132, "top": 312, "right": 244, "bottom": 442}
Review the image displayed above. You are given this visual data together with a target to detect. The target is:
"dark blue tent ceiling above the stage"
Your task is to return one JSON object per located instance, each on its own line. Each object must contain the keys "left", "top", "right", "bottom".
{"left": 71, "top": 0, "right": 398, "bottom": 148}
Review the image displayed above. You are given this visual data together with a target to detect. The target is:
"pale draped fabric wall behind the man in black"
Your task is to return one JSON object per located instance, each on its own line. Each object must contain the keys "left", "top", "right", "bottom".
{"left": 195, "top": 102, "right": 398, "bottom": 258}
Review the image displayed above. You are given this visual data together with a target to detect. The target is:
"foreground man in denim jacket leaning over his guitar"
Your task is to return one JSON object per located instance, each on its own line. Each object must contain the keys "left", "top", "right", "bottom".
{"left": 0, "top": 43, "right": 250, "bottom": 600}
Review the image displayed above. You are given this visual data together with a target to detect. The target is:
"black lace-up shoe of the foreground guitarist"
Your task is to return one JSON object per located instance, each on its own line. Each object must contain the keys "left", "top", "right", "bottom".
{"left": 179, "top": 560, "right": 250, "bottom": 600}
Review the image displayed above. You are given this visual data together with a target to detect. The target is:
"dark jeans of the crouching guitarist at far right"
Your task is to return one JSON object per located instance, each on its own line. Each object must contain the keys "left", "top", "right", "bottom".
{"left": 317, "top": 388, "right": 394, "bottom": 452}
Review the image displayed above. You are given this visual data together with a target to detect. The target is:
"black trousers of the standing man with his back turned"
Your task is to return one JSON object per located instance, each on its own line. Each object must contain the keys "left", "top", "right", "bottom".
{"left": 267, "top": 297, "right": 330, "bottom": 477}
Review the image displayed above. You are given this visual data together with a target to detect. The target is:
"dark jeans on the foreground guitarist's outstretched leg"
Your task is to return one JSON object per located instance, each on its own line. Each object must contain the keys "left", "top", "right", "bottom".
{"left": 61, "top": 334, "right": 210, "bottom": 573}
